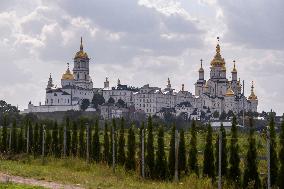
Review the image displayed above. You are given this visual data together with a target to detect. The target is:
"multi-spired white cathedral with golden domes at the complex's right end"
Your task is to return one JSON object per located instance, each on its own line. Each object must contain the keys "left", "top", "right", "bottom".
{"left": 195, "top": 44, "right": 258, "bottom": 113}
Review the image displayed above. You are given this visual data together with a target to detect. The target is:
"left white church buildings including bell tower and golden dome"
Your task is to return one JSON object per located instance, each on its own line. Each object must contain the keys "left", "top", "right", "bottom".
{"left": 24, "top": 37, "right": 95, "bottom": 113}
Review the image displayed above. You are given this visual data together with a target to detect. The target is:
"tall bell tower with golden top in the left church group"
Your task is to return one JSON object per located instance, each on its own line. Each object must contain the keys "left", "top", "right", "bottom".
{"left": 73, "top": 37, "right": 93, "bottom": 89}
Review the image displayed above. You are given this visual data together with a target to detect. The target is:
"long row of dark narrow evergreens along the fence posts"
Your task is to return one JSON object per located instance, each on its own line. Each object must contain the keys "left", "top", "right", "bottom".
{"left": 0, "top": 116, "right": 284, "bottom": 188}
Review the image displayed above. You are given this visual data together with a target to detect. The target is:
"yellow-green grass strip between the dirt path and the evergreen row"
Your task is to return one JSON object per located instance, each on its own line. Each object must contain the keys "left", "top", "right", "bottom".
{"left": 0, "top": 158, "right": 220, "bottom": 189}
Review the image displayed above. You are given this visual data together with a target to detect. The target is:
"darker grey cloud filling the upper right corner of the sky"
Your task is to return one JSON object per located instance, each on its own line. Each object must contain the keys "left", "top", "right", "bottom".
{"left": 218, "top": 0, "right": 284, "bottom": 49}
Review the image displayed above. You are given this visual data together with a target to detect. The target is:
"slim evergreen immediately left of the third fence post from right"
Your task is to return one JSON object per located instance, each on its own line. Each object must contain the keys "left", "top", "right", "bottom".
{"left": 168, "top": 125, "right": 176, "bottom": 178}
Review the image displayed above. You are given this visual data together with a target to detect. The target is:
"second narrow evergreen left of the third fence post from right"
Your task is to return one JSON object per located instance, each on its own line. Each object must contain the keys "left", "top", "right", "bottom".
{"left": 156, "top": 126, "right": 168, "bottom": 180}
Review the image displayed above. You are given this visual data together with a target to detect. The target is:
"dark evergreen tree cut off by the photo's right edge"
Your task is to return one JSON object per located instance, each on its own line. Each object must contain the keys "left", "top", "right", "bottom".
{"left": 278, "top": 119, "right": 284, "bottom": 188}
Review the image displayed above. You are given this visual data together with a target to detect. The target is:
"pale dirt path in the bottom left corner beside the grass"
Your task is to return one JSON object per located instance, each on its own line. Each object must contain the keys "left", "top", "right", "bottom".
{"left": 0, "top": 173, "right": 83, "bottom": 189}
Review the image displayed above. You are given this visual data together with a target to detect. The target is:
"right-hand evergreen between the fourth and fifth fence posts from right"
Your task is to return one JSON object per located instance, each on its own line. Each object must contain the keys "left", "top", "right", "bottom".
{"left": 125, "top": 126, "right": 136, "bottom": 170}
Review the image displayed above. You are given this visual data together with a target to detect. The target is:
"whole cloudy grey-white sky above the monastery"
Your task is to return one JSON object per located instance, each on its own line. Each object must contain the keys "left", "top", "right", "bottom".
{"left": 0, "top": 0, "right": 284, "bottom": 114}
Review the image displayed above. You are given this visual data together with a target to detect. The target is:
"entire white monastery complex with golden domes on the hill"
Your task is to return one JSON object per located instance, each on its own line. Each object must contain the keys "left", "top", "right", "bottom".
{"left": 23, "top": 38, "right": 258, "bottom": 119}
